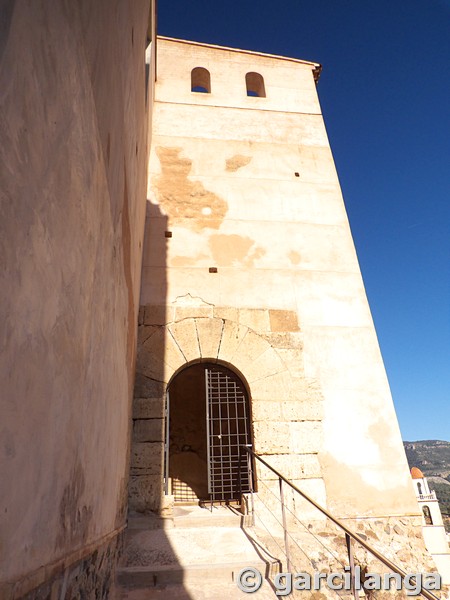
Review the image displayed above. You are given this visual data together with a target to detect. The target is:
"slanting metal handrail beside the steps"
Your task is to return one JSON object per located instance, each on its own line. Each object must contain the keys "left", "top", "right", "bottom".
{"left": 240, "top": 446, "right": 440, "bottom": 600}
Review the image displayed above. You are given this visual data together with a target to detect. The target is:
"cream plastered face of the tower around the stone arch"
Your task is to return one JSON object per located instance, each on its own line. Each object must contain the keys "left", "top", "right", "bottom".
{"left": 138, "top": 39, "right": 418, "bottom": 517}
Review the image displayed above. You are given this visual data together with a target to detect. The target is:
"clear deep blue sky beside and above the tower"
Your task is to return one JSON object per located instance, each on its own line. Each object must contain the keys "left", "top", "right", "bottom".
{"left": 158, "top": 0, "right": 450, "bottom": 440}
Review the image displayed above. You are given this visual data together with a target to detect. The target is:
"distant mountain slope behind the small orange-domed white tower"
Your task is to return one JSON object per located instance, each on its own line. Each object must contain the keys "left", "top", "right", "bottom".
{"left": 403, "top": 440, "right": 450, "bottom": 527}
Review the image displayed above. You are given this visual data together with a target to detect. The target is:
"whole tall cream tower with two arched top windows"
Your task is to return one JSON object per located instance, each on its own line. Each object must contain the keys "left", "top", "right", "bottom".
{"left": 130, "top": 38, "right": 420, "bottom": 540}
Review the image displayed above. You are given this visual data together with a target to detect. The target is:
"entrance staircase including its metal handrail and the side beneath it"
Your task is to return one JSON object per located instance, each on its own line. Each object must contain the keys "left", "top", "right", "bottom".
{"left": 112, "top": 447, "right": 448, "bottom": 600}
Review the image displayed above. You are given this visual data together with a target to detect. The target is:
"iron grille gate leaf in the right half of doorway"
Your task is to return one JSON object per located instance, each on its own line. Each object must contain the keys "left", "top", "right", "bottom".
{"left": 205, "top": 366, "right": 251, "bottom": 502}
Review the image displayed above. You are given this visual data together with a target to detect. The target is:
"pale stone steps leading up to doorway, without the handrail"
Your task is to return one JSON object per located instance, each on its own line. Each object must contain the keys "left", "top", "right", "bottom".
{"left": 114, "top": 506, "right": 278, "bottom": 600}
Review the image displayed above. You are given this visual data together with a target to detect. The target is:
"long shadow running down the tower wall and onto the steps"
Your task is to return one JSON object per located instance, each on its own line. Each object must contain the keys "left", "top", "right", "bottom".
{"left": 115, "top": 200, "right": 191, "bottom": 600}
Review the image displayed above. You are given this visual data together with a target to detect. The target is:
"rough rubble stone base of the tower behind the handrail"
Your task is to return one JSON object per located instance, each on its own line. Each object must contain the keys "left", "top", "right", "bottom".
{"left": 250, "top": 502, "right": 449, "bottom": 600}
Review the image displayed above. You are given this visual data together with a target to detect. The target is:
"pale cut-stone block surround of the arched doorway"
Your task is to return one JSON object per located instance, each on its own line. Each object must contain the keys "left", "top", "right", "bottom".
{"left": 129, "top": 314, "right": 325, "bottom": 511}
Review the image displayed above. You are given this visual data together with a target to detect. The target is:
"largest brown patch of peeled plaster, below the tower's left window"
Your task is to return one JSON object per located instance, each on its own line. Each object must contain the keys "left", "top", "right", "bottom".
{"left": 154, "top": 146, "right": 228, "bottom": 231}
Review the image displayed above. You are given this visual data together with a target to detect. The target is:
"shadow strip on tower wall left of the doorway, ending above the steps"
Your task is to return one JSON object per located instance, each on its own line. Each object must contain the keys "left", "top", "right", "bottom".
{"left": 129, "top": 200, "right": 171, "bottom": 513}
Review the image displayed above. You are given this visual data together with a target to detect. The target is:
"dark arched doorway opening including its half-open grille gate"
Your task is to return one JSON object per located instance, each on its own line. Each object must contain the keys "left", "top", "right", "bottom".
{"left": 165, "top": 363, "right": 252, "bottom": 502}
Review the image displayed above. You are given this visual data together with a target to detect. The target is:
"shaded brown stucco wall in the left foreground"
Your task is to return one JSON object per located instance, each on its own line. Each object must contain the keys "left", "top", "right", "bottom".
{"left": 0, "top": 0, "right": 149, "bottom": 597}
